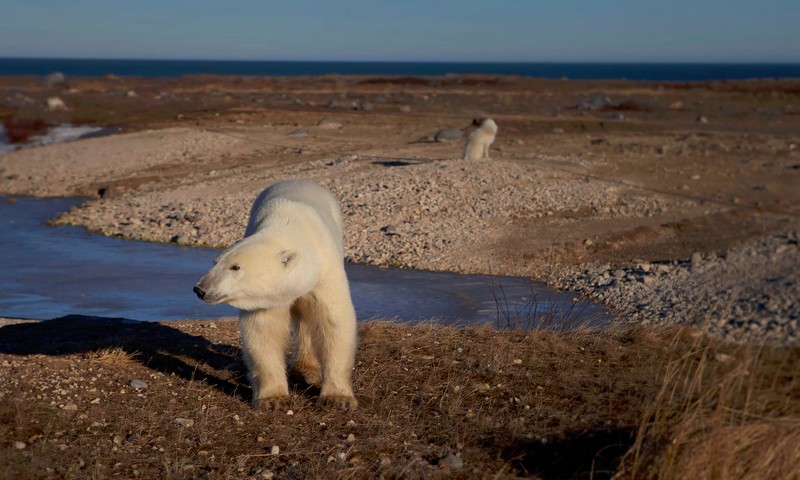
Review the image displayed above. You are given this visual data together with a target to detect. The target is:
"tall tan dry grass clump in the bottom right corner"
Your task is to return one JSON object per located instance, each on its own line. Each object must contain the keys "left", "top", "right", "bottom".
{"left": 619, "top": 339, "right": 800, "bottom": 479}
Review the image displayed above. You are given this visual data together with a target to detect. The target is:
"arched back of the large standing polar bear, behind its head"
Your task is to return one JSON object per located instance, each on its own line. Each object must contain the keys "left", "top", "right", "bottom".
{"left": 245, "top": 180, "right": 344, "bottom": 255}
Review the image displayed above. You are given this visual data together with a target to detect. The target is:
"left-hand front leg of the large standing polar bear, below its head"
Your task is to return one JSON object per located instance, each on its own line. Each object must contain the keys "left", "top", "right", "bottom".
{"left": 239, "top": 308, "right": 290, "bottom": 409}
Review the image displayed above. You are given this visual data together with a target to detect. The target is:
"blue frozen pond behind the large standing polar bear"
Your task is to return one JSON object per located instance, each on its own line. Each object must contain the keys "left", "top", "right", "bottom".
{"left": 0, "top": 197, "right": 609, "bottom": 328}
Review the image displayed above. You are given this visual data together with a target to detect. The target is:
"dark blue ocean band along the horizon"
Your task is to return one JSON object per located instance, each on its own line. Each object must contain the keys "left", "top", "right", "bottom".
{"left": 0, "top": 58, "right": 800, "bottom": 81}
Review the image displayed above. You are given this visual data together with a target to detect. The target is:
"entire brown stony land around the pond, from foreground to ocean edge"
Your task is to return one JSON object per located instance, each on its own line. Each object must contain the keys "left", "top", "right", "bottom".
{"left": 0, "top": 76, "right": 800, "bottom": 478}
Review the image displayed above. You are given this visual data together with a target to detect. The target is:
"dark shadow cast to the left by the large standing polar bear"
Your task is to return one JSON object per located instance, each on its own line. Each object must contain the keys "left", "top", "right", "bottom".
{"left": 0, "top": 315, "right": 319, "bottom": 403}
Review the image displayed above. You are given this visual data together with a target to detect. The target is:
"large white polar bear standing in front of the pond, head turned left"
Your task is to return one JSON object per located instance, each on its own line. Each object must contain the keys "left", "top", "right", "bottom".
{"left": 194, "top": 180, "right": 358, "bottom": 409}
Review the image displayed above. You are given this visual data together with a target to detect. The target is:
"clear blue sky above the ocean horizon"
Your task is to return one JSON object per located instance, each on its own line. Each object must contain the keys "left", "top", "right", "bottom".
{"left": 0, "top": 0, "right": 800, "bottom": 62}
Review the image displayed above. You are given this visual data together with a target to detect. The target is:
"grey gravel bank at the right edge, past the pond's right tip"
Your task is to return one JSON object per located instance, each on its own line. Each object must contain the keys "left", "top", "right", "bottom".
{"left": 554, "top": 228, "right": 800, "bottom": 346}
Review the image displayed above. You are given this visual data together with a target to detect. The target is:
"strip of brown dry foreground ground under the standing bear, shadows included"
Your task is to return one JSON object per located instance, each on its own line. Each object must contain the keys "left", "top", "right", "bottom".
{"left": 0, "top": 316, "right": 800, "bottom": 479}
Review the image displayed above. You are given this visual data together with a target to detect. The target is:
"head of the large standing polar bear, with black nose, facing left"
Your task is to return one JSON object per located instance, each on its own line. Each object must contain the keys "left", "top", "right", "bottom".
{"left": 194, "top": 235, "right": 320, "bottom": 310}
